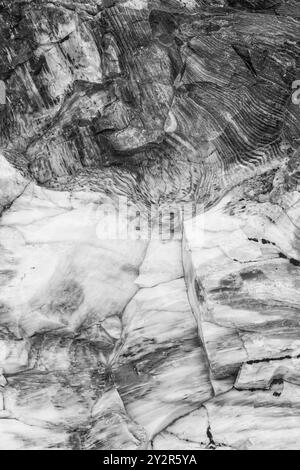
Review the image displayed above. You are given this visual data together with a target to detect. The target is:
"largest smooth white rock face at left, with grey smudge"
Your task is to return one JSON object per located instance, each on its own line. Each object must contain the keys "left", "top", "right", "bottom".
{"left": 0, "top": 186, "right": 147, "bottom": 337}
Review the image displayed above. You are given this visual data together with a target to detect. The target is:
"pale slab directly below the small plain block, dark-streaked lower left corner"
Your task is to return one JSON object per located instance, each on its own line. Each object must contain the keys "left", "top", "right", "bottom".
{"left": 122, "top": 279, "right": 204, "bottom": 360}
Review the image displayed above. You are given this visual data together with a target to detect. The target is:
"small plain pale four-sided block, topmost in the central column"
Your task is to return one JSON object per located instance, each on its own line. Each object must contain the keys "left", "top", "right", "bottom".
{"left": 136, "top": 240, "right": 183, "bottom": 287}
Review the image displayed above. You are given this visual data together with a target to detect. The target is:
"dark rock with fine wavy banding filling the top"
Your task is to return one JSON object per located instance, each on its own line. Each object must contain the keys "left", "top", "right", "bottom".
{"left": 1, "top": 1, "right": 300, "bottom": 202}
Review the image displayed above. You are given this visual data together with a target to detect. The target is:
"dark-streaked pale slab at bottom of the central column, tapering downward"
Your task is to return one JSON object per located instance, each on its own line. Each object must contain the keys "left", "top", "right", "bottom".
{"left": 117, "top": 346, "right": 212, "bottom": 438}
